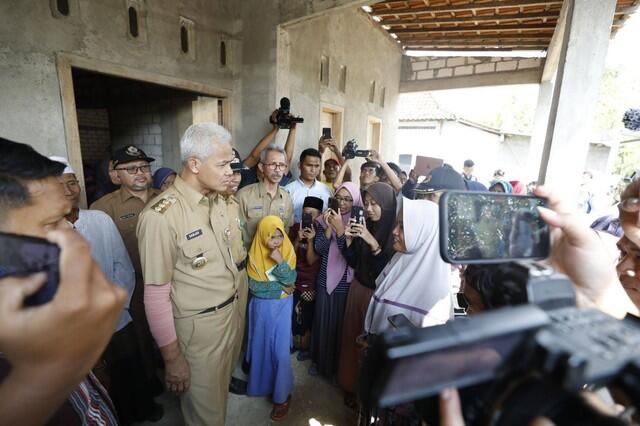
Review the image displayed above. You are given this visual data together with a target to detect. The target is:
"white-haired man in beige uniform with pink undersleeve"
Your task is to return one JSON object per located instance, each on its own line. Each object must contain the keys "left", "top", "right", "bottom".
{"left": 138, "top": 123, "right": 242, "bottom": 425}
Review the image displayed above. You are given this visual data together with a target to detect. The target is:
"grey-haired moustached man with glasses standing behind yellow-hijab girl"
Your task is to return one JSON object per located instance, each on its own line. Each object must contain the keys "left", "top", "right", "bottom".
{"left": 236, "top": 145, "right": 293, "bottom": 249}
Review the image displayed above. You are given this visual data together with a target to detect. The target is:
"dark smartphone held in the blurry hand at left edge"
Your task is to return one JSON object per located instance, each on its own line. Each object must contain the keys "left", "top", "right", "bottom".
{"left": 0, "top": 232, "right": 60, "bottom": 306}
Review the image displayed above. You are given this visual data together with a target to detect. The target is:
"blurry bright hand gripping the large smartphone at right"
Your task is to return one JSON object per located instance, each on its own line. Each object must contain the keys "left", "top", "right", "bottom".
{"left": 535, "top": 186, "right": 631, "bottom": 318}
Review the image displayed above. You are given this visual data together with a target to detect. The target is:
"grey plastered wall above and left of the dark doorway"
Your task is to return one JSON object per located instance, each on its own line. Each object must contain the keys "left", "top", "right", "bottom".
{"left": 0, "top": 0, "right": 240, "bottom": 155}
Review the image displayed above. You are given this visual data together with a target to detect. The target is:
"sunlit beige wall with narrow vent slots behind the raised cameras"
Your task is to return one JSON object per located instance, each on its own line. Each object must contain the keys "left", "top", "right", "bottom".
{"left": 277, "top": 9, "right": 402, "bottom": 176}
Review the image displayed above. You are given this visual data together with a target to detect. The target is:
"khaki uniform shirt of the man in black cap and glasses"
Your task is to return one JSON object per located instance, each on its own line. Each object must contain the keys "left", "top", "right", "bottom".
{"left": 90, "top": 188, "right": 160, "bottom": 274}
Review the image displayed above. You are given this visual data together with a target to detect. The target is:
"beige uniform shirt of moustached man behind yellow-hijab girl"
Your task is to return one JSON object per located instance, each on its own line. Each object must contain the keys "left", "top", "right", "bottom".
{"left": 236, "top": 182, "right": 293, "bottom": 249}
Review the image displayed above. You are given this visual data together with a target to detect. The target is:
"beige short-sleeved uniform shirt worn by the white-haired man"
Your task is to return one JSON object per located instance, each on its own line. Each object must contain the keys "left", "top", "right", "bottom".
{"left": 137, "top": 176, "right": 238, "bottom": 318}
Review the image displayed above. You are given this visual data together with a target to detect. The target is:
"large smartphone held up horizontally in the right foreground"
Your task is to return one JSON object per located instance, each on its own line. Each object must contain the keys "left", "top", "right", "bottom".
{"left": 440, "top": 191, "right": 550, "bottom": 264}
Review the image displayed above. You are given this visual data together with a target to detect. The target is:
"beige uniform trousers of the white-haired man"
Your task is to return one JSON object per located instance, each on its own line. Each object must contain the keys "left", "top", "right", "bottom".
{"left": 175, "top": 299, "right": 244, "bottom": 426}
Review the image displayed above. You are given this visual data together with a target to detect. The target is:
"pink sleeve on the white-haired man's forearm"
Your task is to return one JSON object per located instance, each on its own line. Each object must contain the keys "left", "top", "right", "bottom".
{"left": 144, "top": 283, "right": 178, "bottom": 347}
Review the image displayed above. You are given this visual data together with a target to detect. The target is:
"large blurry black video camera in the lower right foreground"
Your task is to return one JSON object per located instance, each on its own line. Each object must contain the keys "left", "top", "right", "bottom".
{"left": 368, "top": 263, "right": 640, "bottom": 425}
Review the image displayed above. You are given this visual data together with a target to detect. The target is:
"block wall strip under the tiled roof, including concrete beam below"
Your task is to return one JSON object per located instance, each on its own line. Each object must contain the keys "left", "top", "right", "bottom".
{"left": 400, "top": 56, "right": 544, "bottom": 92}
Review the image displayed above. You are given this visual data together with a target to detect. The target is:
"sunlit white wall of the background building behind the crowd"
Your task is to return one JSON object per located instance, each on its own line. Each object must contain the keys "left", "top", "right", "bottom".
{"left": 394, "top": 121, "right": 611, "bottom": 184}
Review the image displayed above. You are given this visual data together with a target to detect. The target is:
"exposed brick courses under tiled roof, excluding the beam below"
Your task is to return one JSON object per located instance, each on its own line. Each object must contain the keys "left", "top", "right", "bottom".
{"left": 405, "top": 56, "right": 544, "bottom": 81}
